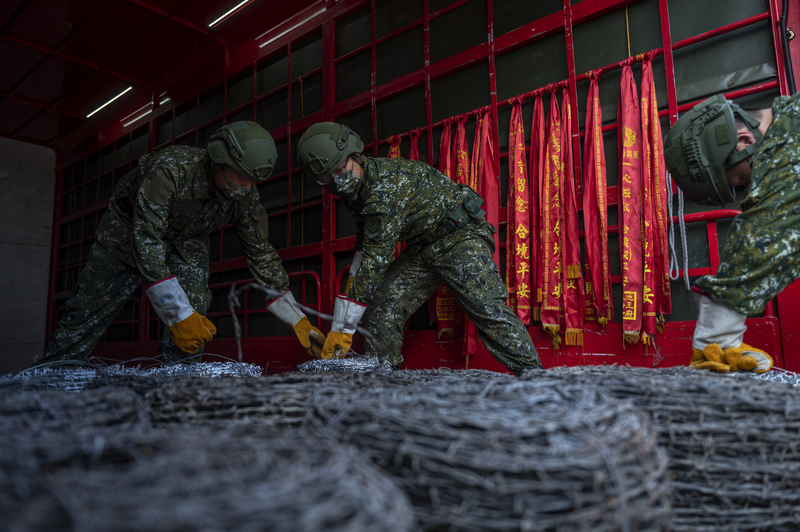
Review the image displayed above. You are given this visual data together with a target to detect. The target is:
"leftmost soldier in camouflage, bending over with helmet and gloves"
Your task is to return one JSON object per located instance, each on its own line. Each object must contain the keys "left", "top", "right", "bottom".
{"left": 40, "top": 122, "right": 325, "bottom": 363}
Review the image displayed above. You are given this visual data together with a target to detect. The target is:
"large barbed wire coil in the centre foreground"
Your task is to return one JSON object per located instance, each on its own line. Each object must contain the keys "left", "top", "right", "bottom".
{"left": 315, "top": 372, "right": 669, "bottom": 531}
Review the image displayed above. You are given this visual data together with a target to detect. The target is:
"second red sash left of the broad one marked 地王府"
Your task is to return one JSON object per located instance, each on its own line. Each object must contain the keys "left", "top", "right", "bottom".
{"left": 561, "top": 87, "right": 585, "bottom": 345}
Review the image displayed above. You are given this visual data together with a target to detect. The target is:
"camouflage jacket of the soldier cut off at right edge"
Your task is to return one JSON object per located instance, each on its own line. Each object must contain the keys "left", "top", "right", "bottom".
{"left": 695, "top": 93, "right": 800, "bottom": 315}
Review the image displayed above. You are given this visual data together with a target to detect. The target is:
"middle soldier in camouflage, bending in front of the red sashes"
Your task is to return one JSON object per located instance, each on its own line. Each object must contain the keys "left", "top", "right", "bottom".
{"left": 297, "top": 122, "right": 541, "bottom": 375}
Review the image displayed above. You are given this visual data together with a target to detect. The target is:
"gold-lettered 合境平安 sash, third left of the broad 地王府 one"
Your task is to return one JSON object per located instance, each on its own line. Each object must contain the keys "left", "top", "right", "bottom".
{"left": 541, "top": 87, "right": 564, "bottom": 347}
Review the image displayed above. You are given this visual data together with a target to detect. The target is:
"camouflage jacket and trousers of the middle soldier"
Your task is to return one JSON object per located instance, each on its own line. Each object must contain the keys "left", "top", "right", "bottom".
{"left": 345, "top": 157, "right": 541, "bottom": 373}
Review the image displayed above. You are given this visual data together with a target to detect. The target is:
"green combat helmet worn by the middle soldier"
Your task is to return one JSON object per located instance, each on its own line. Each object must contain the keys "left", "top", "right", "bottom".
{"left": 297, "top": 122, "right": 364, "bottom": 177}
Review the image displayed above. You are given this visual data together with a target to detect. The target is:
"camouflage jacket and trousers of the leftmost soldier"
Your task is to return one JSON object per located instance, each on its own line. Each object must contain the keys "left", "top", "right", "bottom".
{"left": 46, "top": 146, "right": 289, "bottom": 362}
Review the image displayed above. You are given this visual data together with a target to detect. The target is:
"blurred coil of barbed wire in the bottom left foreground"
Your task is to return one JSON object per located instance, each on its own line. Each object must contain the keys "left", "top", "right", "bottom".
{"left": 0, "top": 388, "right": 417, "bottom": 532}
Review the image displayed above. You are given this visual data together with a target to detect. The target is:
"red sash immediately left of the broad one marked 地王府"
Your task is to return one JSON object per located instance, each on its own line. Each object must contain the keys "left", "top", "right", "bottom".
{"left": 583, "top": 72, "right": 614, "bottom": 325}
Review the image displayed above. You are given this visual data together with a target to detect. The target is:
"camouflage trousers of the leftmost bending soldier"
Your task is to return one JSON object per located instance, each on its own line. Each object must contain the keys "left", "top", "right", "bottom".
{"left": 40, "top": 241, "right": 211, "bottom": 364}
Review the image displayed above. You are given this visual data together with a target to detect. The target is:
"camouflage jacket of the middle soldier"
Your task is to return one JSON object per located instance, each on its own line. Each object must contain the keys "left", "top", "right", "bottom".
{"left": 344, "top": 157, "right": 478, "bottom": 304}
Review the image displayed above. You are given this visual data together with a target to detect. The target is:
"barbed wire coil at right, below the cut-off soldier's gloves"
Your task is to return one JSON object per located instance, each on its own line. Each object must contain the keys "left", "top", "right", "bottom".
{"left": 541, "top": 367, "right": 800, "bottom": 532}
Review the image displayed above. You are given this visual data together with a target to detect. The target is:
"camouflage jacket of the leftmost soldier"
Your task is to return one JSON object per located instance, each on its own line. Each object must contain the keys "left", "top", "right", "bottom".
{"left": 98, "top": 146, "right": 289, "bottom": 290}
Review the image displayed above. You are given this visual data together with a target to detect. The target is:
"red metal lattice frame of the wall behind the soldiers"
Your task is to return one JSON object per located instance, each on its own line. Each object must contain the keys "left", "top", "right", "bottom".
{"left": 48, "top": 0, "right": 800, "bottom": 371}
